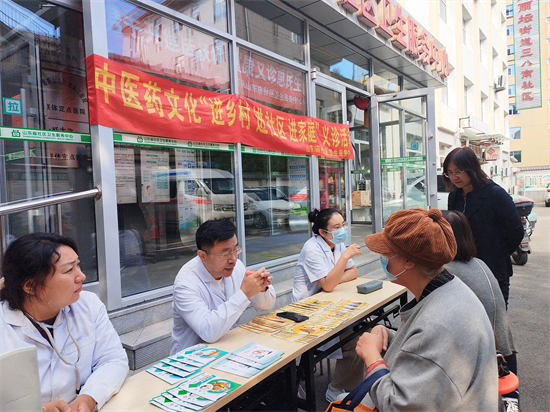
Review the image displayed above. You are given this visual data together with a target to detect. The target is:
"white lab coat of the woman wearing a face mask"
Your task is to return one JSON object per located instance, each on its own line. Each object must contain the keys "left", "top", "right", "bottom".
{"left": 292, "top": 235, "right": 355, "bottom": 302}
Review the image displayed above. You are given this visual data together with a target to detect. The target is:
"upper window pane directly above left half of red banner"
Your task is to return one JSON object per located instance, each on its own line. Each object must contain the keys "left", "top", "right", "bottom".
{"left": 105, "top": 0, "right": 230, "bottom": 93}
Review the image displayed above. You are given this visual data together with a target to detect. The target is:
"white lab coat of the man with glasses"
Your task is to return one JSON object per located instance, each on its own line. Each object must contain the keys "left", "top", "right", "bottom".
{"left": 170, "top": 256, "right": 276, "bottom": 354}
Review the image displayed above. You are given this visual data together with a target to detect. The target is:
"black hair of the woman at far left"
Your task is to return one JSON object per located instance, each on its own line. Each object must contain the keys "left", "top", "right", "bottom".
{"left": 0, "top": 233, "right": 78, "bottom": 310}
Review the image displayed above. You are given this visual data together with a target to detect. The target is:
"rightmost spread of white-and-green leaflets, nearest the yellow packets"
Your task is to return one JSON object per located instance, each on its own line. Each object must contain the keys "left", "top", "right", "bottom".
{"left": 211, "top": 342, "right": 284, "bottom": 378}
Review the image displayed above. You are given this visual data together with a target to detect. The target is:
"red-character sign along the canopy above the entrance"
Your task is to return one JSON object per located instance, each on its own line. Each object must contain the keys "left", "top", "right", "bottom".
{"left": 338, "top": 0, "right": 449, "bottom": 78}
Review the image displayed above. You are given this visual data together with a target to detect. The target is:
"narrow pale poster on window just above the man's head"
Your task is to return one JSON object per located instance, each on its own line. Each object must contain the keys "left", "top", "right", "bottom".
{"left": 174, "top": 149, "right": 198, "bottom": 230}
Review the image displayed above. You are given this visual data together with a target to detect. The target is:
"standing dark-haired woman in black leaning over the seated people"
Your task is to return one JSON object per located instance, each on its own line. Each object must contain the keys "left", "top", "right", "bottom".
{"left": 443, "top": 147, "right": 523, "bottom": 305}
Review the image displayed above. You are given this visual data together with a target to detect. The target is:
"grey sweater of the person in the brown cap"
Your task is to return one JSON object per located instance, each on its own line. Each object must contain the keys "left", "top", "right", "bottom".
{"left": 370, "top": 277, "right": 498, "bottom": 412}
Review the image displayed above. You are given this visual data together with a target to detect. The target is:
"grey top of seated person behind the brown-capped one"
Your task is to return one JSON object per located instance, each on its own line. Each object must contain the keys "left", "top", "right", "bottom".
{"left": 446, "top": 258, "right": 516, "bottom": 356}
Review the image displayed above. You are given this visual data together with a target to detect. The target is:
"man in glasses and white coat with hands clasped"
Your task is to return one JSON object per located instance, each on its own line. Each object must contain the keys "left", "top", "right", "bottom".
{"left": 170, "top": 219, "right": 276, "bottom": 354}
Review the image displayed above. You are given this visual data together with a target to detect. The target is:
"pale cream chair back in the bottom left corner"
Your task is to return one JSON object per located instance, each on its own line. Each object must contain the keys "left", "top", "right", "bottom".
{"left": 0, "top": 346, "right": 42, "bottom": 412}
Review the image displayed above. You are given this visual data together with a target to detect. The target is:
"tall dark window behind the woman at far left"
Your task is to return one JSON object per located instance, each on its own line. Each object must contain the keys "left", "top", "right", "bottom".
{"left": 0, "top": 0, "right": 98, "bottom": 282}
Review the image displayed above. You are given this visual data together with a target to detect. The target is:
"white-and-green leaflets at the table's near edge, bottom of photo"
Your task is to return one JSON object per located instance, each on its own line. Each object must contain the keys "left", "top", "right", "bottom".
{"left": 149, "top": 372, "right": 241, "bottom": 412}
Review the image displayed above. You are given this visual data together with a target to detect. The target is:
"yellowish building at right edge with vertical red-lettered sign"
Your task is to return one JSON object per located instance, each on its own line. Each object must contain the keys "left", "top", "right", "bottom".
{"left": 506, "top": 0, "right": 550, "bottom": 200}
